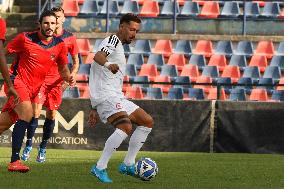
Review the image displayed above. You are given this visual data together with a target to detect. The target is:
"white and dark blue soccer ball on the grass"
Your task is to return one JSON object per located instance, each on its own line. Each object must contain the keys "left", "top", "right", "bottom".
{"left": 135, "top": 157, "right": 158, "bottom": 181}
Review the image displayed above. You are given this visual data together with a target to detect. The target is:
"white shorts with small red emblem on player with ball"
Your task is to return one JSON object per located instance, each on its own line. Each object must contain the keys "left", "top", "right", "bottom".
{"left": 96, "top": 97, "right": 139, "bottom": 123}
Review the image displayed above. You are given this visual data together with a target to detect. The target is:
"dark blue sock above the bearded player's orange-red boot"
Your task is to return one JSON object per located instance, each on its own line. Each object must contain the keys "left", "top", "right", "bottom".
{"left": 11, "top": 119, "right": 30, "bottom": 163}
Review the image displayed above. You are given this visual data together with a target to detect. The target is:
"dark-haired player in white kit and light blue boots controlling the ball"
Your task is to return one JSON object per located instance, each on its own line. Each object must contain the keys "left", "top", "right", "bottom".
{"left": 89, "top": 13, "right": 154, "bottom": 183}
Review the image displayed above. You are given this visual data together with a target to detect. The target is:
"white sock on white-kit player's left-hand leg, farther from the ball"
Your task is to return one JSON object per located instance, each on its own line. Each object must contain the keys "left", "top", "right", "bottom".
{"left": 97, "top": 129, "right": 127, "bottom": 169}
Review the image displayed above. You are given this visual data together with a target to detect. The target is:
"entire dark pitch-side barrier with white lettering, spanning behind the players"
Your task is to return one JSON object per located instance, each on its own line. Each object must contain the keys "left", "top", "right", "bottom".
{"left": 0, "top": 99, "right": 284, "bottom": 153}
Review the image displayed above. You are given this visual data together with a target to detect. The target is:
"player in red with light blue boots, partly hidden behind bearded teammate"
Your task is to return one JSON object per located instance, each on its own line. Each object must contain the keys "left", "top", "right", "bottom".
{"left": 21, "top": 7, "right": 79, "bottom": 163}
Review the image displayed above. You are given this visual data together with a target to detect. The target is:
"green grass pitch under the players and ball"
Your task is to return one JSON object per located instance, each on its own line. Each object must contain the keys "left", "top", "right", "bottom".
{"left": 0, "top": 148, "right": 284, "bottom": 189}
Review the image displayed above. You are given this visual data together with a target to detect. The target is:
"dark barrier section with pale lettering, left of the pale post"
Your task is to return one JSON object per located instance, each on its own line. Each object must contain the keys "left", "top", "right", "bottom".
{"left": 0, "top": 99, "right": 210, "bottom": 152}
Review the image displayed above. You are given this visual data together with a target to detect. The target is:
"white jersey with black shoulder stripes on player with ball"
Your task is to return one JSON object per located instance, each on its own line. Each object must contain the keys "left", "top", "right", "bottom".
{"left": 89, "top": 35, "right": 126, "bottom": 106}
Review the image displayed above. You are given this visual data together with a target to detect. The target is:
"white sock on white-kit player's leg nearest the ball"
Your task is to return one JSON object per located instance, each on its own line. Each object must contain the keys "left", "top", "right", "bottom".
{"left": 123, "top": 126, "right": 152, "bottom": 166}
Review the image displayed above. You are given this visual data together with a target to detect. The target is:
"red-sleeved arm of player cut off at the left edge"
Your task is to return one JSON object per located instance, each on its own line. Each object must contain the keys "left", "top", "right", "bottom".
{"left": 0, "top": 18, "right": 19, "bottom": 101}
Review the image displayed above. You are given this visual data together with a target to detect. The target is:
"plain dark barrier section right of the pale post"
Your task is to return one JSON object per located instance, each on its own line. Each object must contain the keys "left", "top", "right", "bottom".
{"left": 215, "top": 102, "right": 284, "bottom": 153}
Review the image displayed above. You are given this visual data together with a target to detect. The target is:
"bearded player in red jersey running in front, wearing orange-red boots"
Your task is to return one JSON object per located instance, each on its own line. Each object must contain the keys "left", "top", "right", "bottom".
{"left": 0, "top": 11, "right": 75, "bottom": 172}
